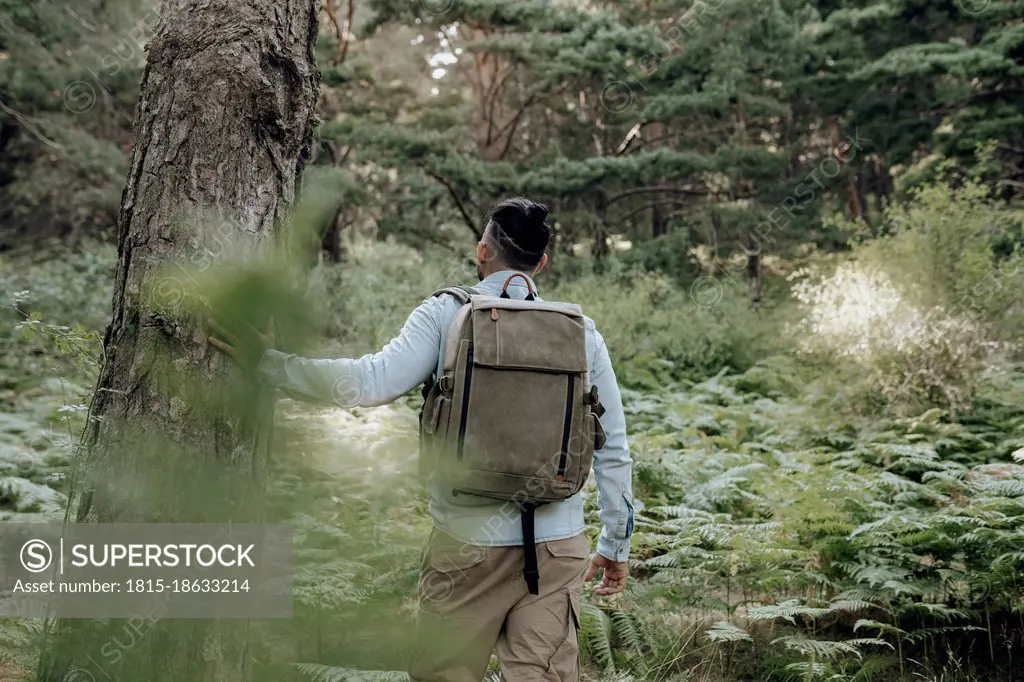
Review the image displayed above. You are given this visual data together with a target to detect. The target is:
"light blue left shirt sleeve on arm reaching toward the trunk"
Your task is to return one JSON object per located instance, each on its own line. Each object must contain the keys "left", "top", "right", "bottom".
{"left": 256, "top": 298, "right": 444, "bottom": 408}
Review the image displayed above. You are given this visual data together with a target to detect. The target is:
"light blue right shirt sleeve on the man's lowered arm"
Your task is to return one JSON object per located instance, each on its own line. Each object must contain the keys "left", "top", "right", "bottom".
{"left": 591, "top": 333, "right": 633, "bottom": 561}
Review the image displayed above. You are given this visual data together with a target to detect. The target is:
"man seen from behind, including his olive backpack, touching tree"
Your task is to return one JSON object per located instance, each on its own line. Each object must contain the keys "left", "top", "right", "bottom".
{"left": 211, "top": 199, "right": 633, "bottom": 682}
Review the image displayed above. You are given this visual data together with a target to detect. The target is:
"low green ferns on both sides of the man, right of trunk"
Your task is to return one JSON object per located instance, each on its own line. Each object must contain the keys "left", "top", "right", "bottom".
{"left": 262, "top": 359, "right": 1024, "bottom": 682}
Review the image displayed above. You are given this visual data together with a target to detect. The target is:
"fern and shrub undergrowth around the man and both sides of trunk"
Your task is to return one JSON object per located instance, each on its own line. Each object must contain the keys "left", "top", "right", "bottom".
{"left": 0, "top": 235, "right": 1024, "bottom": 682}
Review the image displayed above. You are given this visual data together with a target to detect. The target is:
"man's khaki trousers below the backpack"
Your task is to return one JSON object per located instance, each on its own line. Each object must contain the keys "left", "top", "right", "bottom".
{"left": 409, "top": 529, "right": 590, "bottom": 682}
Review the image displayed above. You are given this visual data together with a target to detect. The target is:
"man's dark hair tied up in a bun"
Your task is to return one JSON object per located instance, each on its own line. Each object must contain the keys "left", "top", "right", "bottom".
{"left": 486, "top": 197, "right": 551, "bottom": 270}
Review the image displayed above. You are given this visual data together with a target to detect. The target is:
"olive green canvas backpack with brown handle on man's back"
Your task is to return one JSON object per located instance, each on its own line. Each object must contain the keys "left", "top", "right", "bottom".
{"left": 420, "top": 273, "right": 604, "bottom": 594}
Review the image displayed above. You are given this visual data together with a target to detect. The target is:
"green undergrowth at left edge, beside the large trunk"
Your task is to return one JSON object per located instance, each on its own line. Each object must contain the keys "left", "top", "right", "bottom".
{"left": 0, "top": 238, "right": 115, "bottom": 522}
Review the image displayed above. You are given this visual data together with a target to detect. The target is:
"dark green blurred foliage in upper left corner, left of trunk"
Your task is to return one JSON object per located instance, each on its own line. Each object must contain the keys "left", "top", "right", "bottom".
{"left": 0, "top": 0, "right": 146, "bottom": 249}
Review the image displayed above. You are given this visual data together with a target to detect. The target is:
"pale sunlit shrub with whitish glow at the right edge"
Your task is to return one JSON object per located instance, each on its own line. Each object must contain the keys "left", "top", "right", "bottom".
{"left": 792, "top": 182, "right": 1024, "bottom": 414}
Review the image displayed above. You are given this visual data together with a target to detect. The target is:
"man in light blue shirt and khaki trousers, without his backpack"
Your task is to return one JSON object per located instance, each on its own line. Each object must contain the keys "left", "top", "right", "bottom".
{"left": 210, "top": 198, "right": 633, "bottom": 682}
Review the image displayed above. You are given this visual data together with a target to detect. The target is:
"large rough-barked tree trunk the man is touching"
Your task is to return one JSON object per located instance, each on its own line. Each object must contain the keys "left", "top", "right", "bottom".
{"left": 37, "top": 0, "right": 319, "bottom": 682}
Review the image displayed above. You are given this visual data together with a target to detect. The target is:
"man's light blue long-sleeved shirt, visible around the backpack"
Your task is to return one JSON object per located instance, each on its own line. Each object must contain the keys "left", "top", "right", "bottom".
{"left": 258, "top": 270, "right": 633, "bottom": 561}
